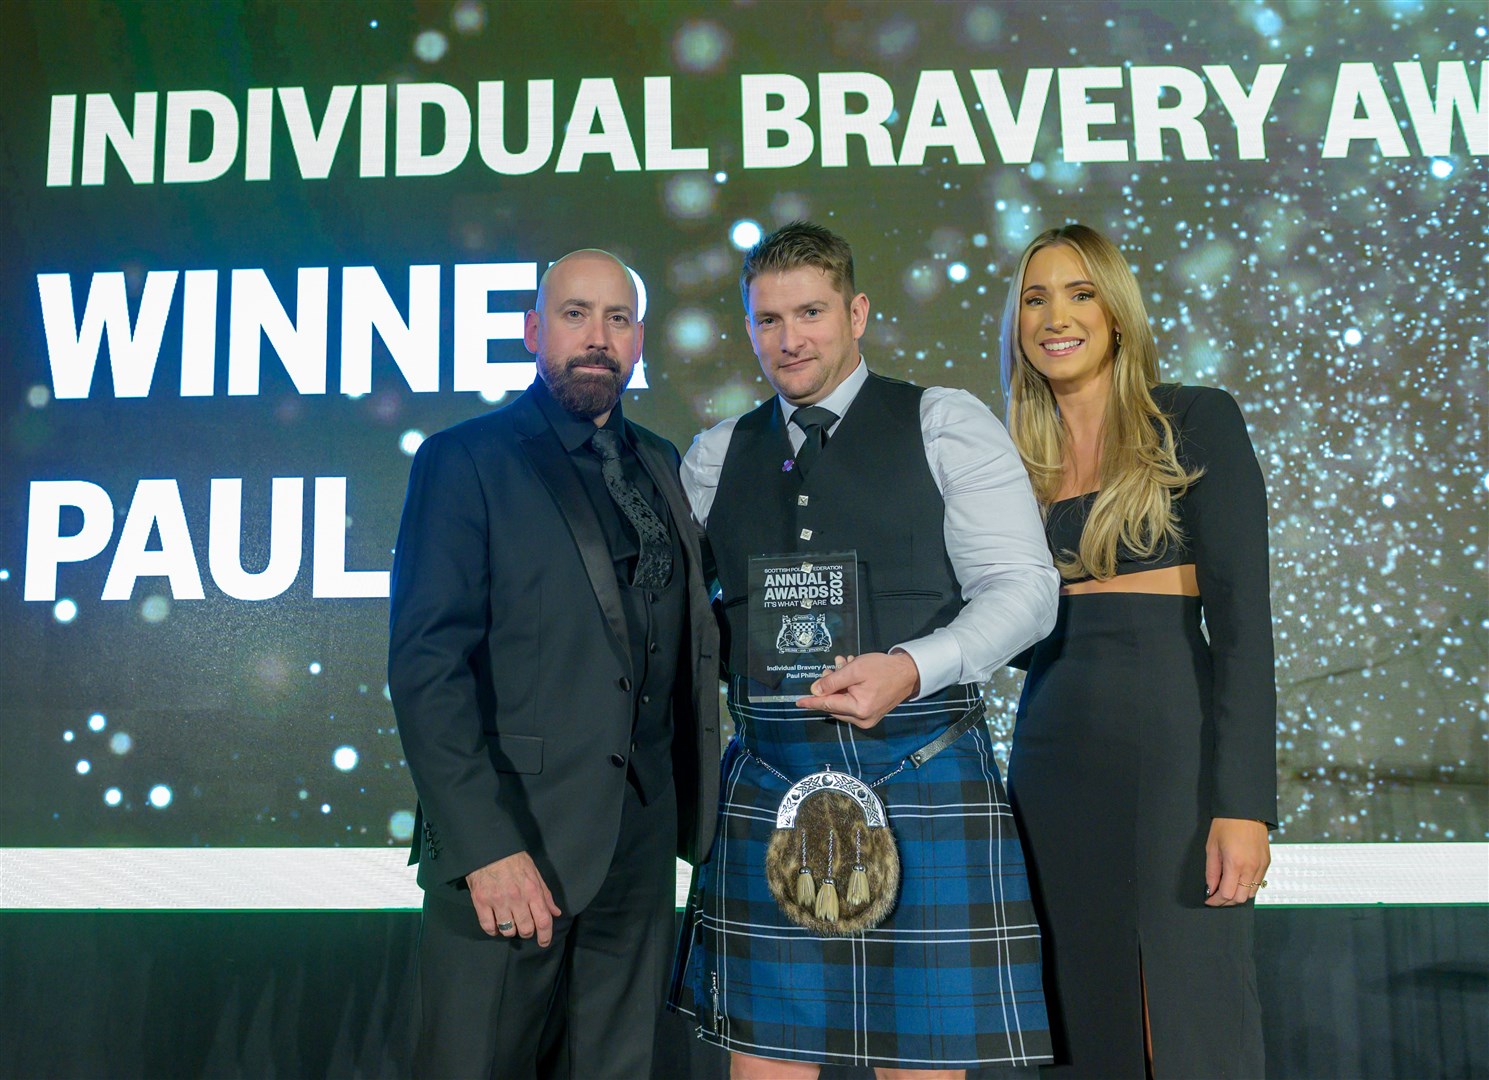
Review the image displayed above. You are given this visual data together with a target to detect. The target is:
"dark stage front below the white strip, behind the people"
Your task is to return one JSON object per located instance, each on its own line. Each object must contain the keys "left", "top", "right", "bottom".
{"left": 0, "top": 906, "right": 1489, "bottom": 1080}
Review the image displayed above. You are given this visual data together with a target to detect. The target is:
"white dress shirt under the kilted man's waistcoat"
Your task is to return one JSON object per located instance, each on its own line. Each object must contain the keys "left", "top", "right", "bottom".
{"left": 682, "top": 358, "right": 1060, "bottom": 697}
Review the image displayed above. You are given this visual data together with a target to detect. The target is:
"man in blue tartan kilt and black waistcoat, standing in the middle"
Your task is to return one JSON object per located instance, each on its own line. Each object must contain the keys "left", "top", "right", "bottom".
{"left": 669, "top": 222, "right": 1059, "bottom": 1079}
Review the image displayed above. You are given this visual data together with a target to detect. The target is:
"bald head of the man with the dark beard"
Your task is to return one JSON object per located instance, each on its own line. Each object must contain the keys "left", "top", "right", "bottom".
{"left": 523, "top": 247, "right": 642, "bottom": 425}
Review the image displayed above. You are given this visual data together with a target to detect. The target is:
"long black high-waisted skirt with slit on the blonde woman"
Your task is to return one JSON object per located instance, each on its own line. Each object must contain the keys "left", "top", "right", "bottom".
{"left": 1008, "top": 593, "right": 1264, "bottom": 1080}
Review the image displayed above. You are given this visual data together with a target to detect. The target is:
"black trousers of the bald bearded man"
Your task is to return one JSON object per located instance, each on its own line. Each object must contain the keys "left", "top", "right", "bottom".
{"left": 414, "top": 785, "right": 677, "bottom": 1080}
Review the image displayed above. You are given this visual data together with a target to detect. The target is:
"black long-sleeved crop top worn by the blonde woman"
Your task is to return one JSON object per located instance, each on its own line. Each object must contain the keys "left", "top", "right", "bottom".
{"left": 1045, "top": 386, "right": 1278, "bottom": 822}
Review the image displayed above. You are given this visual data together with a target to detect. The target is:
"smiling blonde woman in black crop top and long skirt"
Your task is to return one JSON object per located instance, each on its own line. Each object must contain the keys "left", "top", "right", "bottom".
{"left": 1001, "top": 225, "right": 1276, "bottom": 1079}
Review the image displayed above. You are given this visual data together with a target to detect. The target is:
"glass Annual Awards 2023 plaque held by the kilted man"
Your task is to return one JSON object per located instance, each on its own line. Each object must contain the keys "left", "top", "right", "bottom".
{"left": 747, "top": 551, "right": 858, "bottom": 702}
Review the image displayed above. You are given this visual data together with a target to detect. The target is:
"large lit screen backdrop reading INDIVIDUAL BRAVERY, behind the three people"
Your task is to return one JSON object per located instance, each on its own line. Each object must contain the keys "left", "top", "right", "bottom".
{"left": 0, "top": 0, "right": 1489, "bottom": 906}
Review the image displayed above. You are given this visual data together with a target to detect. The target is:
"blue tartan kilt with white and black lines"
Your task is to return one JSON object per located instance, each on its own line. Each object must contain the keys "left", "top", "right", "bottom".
{"left": 667, "top": 685, "right": 1051, "bottom": 1068}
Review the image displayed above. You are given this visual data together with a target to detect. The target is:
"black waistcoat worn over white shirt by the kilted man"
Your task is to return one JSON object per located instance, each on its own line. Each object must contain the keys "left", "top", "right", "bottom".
{"left": 707, "top": 374, "right": 962, "bottom": 673}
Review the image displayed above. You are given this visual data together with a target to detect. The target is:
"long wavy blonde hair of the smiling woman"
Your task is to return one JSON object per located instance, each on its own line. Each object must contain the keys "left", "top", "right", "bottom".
{"left": 999, "top": 225, "right": 1200, "bottom": 579}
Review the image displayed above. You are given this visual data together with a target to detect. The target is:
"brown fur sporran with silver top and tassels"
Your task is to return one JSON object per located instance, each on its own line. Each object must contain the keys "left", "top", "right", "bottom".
{"left": 765, "top": 770, "right": 899, "bottom": 936}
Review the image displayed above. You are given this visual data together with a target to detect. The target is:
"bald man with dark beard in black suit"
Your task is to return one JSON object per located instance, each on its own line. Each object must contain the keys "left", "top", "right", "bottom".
{"left": 389, "top": 249, "right": 719, "bottom": 1079}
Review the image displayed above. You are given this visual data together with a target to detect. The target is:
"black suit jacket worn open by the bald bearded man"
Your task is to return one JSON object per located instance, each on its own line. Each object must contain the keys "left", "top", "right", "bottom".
{"left": 389, "top": 393, "right": 719, "bottom": 913}
